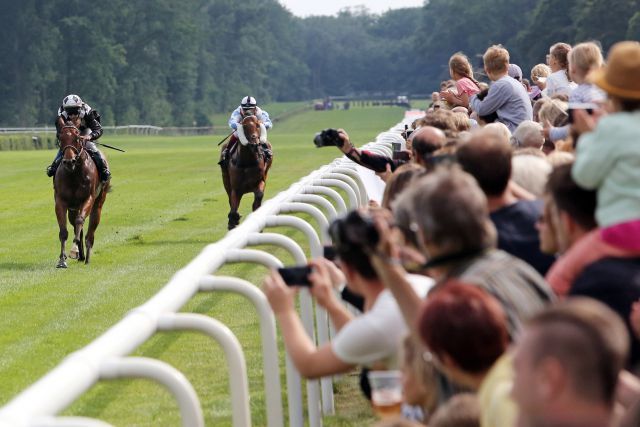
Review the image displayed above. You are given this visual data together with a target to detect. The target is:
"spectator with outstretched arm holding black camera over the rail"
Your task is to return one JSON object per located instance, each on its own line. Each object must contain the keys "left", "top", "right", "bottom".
{"left": 314, "top": 126, "right": 446, "bottom": 181}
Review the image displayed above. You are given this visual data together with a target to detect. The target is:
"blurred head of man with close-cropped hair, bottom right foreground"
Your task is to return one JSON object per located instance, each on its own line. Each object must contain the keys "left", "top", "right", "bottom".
{"left": 512, "top": 299, "right": 629, "bottom": 427}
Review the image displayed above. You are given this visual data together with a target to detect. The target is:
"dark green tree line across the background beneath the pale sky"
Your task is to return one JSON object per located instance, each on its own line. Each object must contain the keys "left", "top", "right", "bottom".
{"left": 0, "top": 0, "right": 640, "bottom": 126}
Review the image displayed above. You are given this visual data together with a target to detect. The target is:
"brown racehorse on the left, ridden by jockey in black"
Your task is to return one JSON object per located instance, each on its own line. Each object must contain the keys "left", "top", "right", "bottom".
{"left": 53, "top": 118, "right": 109, "bottom": 268}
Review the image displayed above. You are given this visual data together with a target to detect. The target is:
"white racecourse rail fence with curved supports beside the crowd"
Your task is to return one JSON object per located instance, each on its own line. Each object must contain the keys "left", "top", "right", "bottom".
{"left": 0, "top": 123, "right": 404, "bottom": 427}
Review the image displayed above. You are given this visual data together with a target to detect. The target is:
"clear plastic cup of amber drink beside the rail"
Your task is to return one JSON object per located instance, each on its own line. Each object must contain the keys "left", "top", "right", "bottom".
{"left": 369, "top": 371, "right": 402, "bottom": 418}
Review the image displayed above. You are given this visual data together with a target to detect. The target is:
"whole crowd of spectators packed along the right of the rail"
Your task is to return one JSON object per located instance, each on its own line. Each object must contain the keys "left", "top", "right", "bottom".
{"left": 263, "top": 41, "right": 640, "bottom": 427}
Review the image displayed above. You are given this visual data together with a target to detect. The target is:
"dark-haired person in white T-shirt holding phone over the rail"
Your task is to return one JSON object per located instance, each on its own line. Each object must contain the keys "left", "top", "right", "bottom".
{"left": 263, "top": 211, "right": 432, "bottom": 378}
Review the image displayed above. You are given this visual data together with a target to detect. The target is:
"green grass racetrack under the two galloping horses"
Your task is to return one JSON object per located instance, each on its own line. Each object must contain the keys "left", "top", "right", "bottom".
{"left": 0, "top": 107, "right": 403, "bottom": 426}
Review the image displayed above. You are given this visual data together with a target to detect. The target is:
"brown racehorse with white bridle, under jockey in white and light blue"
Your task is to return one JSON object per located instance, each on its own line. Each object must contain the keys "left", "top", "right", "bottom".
{"left": 222, "top": 116, "right": 272, "bottom": 230}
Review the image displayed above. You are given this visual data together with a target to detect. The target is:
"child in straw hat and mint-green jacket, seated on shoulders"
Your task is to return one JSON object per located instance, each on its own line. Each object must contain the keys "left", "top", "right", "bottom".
{"left": 547, "top": 41, "right": 640, "bottom": 294}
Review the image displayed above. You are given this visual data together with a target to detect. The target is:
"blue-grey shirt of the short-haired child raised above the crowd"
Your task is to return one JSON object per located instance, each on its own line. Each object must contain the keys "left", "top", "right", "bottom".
{"left": 469, "top": 75, "right": 533, "bottom": 133}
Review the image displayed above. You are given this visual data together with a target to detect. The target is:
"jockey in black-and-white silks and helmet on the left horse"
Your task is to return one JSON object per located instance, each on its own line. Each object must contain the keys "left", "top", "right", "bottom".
{"left": 47, "top": 94, "right": 111, "bottom": 182}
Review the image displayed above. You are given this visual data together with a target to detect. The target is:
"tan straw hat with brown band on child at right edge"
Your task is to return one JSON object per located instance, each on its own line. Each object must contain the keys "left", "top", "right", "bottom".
{"left": 588, "top": 41, "right": 640, "bottom": 100}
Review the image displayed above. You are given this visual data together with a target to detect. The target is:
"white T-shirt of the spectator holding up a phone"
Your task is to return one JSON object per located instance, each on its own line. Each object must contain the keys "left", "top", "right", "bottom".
{"left": 331, "top": 274, "right": 434, "bottom": 369}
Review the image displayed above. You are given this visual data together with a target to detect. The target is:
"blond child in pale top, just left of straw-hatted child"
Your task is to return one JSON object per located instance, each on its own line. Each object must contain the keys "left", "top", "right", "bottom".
{"left": 543, "top": 42, "right": 607, "bottom": 142}
